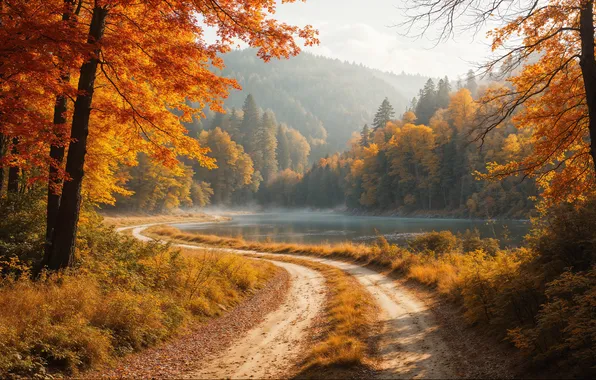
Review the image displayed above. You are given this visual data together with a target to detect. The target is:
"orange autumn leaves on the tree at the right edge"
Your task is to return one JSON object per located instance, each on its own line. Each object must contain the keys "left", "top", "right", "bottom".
{"left": 481, "top": 0, "right": 595, "bottom": 205}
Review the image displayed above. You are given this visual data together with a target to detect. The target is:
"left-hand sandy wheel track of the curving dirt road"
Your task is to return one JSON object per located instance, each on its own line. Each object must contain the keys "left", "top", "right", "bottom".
{"left": 120, "top": 225, "right": 325, "bottom": 379}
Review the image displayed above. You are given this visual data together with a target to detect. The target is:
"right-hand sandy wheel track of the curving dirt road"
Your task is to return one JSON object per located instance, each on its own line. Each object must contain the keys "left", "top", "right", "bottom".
{"left": 133, "top": 226, "right": 462, "bottom": 379}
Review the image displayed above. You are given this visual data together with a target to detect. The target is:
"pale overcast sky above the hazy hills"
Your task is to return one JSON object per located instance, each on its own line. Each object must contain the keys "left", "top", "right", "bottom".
{"left": 276, "top": 0, "right": 490, "bottom": 80}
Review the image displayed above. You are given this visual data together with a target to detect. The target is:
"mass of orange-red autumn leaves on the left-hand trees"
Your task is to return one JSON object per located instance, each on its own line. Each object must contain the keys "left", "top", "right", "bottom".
{"left": 0, "top": 0, "right": 317, "bottom": 202}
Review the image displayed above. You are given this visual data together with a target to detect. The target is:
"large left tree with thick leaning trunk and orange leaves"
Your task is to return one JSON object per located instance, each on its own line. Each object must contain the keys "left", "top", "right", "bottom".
{"left": 36, "top": 0, "right": 316, "bottom": 269}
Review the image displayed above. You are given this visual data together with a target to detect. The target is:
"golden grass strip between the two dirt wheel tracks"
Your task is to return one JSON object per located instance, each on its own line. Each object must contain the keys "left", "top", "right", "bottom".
{"left": 251, "top": 256, "right": 378, "bottom": 378}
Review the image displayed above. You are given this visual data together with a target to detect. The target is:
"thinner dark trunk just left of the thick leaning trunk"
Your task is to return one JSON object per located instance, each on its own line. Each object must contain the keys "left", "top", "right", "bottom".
{"left": 43, "top": 0, "right": 74, "bottom": 265}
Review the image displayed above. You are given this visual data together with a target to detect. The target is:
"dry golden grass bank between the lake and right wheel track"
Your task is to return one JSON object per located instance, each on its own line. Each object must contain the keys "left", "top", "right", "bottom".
{"left": 147, "top": 226, "right": 531, "bottom": 323}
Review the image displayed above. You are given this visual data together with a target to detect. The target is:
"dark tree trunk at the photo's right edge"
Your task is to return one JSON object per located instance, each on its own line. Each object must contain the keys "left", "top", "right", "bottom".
{"left": 579, "top": 0, "right": 596, "bottom": 168}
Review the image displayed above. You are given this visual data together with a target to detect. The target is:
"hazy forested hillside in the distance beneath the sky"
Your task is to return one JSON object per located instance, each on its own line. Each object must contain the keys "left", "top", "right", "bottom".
{"left": 217, "top": 49, "right": 428, "bottom": 153}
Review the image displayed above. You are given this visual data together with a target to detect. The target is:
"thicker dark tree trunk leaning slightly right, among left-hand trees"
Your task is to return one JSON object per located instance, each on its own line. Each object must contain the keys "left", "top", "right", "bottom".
{"left": 48, "top": 7, "right": 108, "bottom": 270}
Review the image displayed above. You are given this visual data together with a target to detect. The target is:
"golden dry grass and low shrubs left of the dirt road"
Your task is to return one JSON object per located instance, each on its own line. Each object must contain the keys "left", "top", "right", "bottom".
{"left": 0, "top": 235, "right": 279, "bottom": 378}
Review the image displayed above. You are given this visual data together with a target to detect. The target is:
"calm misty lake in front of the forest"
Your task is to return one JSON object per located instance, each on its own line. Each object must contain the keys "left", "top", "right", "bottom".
{"left": 174, "top": 211, "right": 530, "bottom": 245}
